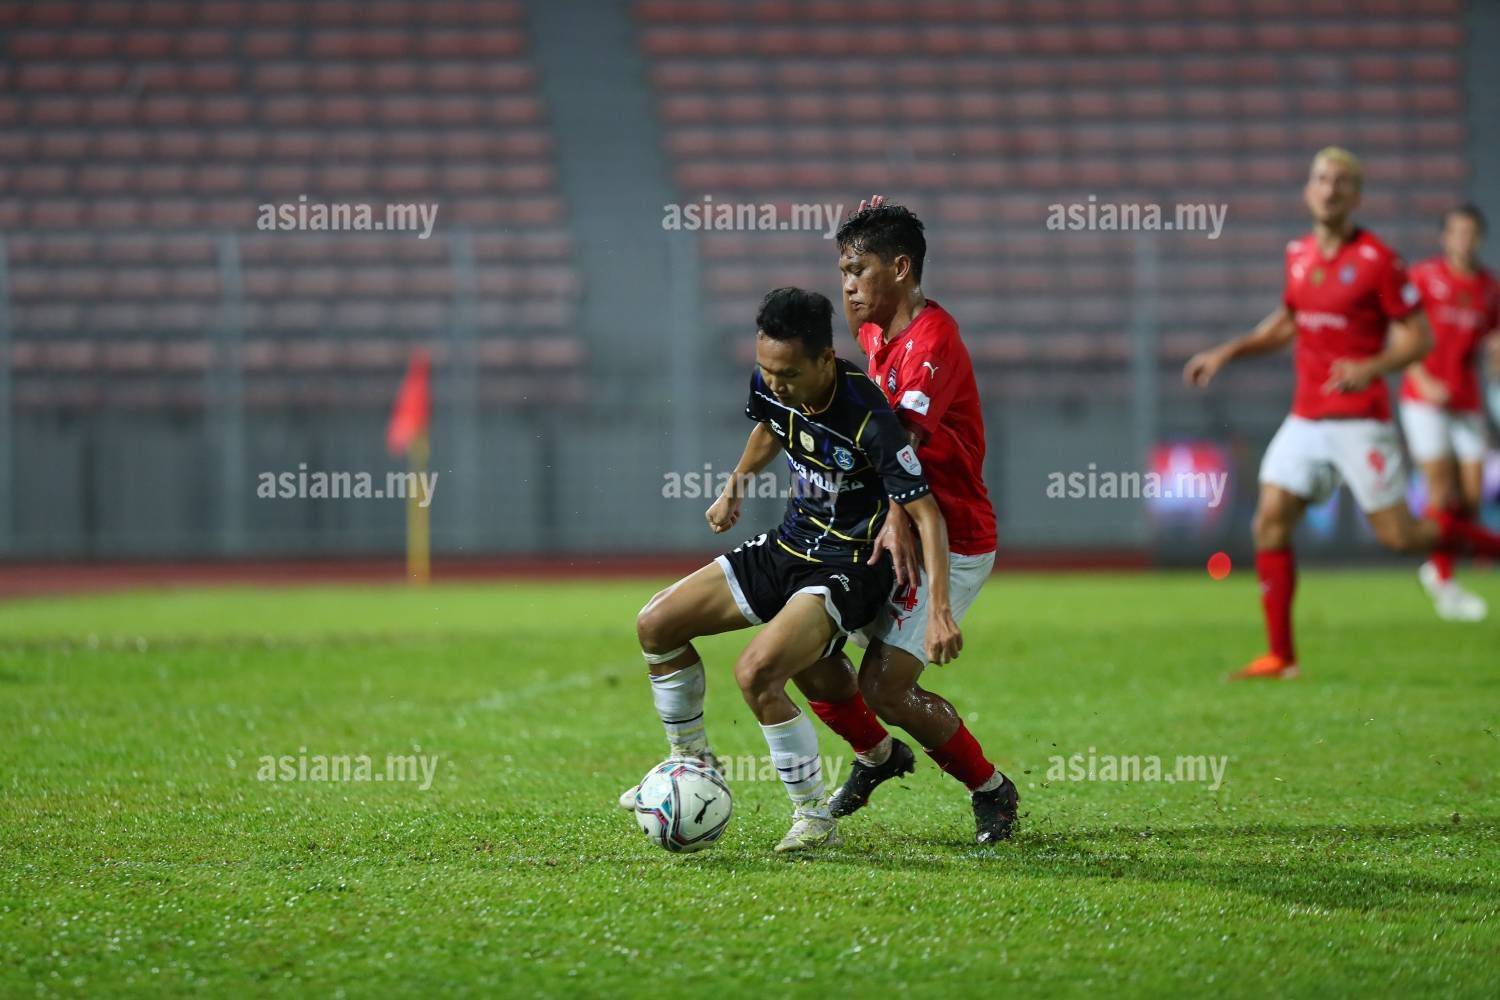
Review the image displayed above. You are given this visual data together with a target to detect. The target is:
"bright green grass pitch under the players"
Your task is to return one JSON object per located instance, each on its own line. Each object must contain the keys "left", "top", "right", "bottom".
{"left": 0, "top": 570, "right": 1500, "bottom": 997}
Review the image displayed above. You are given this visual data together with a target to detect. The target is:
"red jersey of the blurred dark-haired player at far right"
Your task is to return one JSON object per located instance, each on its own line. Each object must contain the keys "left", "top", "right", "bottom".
{"left": 1401, "top": 256, "right": 1500, "bottom": 412}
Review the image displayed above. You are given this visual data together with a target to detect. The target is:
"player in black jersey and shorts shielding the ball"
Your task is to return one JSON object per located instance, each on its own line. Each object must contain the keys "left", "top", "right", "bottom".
{"left": 621, "top": 288, "right": 963, "bottom": 852}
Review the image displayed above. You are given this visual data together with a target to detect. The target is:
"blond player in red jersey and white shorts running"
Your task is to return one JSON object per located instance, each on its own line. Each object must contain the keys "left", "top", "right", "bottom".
{"left": 1184, "top": 147, "right": 1500, "bottom": 679}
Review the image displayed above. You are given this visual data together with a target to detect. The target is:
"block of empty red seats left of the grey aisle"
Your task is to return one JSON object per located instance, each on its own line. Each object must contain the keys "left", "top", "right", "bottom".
{"left": 0, "top": 0, "right": 588, "bottom": 406}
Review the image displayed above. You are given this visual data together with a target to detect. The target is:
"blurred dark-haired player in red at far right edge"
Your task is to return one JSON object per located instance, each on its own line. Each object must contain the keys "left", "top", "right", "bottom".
{"left": 1401, "top": 205, "right": 1500, "bottom": 621}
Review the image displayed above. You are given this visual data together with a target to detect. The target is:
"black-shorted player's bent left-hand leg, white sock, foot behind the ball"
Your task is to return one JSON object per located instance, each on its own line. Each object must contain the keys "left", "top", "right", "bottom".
{"left": 620, "top": 562, "right": 752, "bottom": 810}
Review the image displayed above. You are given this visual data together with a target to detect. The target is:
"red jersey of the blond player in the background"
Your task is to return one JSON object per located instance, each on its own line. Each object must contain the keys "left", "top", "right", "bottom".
{"left": 1281, "top": 229, "right": 1421, "bottom": 420}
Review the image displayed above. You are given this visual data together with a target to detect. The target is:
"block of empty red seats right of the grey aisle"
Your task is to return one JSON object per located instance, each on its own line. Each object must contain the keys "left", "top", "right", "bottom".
{"left": 635, "top": 0, "right": 1467, "bottom": 374}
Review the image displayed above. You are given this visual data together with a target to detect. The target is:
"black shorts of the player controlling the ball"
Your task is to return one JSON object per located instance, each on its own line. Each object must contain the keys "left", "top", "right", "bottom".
{"left": 714, "top": 532, "right": 896, "bottom": 657}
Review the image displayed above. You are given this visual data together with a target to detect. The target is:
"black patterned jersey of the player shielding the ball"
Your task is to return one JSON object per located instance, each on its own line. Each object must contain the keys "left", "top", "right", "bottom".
{"left": 746, "top": 358, "right": 929, "bottom": 562}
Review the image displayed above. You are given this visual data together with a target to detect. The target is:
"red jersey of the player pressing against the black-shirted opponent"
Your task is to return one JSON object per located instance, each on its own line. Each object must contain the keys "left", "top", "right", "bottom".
{"left": 858, "top": 298, "right": 996, "bottom": 556}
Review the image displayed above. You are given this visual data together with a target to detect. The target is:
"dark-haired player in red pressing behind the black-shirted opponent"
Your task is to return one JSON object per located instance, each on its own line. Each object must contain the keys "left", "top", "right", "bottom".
{"left": 797, "top": 196, "right": 1017, "bottom": 844}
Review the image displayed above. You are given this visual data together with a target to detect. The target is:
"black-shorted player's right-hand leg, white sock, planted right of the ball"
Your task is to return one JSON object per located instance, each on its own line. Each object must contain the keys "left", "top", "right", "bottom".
{"left": 735, "top": 591, "right": 843, "bottom": 852}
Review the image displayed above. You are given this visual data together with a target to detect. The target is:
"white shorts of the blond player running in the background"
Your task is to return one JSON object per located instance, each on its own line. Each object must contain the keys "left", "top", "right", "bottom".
{"left": 1260, "top": 415, "right": 1407, "bottom": 514}
